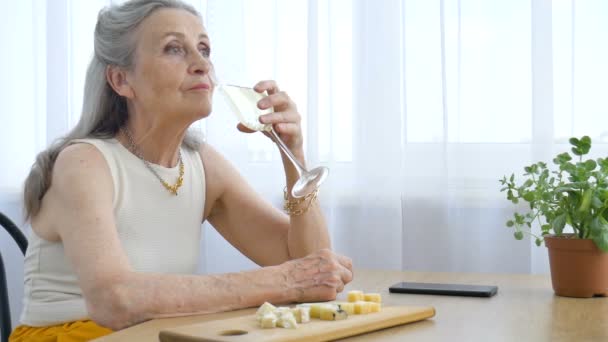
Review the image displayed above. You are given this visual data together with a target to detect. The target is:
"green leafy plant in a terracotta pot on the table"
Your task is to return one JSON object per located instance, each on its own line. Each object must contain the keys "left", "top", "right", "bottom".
{"left": 500, "top": 136, "right": 608, "bottom": 297}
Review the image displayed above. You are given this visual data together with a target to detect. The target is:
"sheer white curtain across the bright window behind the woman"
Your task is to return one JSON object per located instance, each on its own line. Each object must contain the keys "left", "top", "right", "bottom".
{"left": 0, "top": 0, "right": 608, "bottom": 308}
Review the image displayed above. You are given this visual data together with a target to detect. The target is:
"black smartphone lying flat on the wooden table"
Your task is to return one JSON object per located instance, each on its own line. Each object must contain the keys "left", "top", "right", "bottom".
{"left": 388, "top": 282, "right": 498, "bottom": 297}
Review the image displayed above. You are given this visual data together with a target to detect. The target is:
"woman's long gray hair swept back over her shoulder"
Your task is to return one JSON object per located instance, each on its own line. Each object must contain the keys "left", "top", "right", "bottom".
{"left": 23, "top": 0, "right": 201, "bottom": 220}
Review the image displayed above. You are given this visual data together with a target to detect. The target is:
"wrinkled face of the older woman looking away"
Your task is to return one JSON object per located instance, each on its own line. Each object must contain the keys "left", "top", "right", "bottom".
{"left": 126, "top": 9, "right": 214, "bottom": 122}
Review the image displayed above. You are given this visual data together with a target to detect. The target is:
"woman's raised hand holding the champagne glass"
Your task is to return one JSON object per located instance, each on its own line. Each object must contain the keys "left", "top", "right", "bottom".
{"left": 237, "top": 81, "right": 304, "bottom": 156}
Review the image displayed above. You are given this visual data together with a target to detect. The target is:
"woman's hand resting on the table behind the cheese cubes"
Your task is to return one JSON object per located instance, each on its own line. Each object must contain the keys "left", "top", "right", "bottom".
{"left": 279, "top": 249, "right": 353, "bottom": 302}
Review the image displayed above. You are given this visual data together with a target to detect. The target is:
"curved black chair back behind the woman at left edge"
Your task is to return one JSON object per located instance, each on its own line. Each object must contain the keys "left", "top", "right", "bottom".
{"left": 0, "top": 213, "right": 27, "bottom": 342}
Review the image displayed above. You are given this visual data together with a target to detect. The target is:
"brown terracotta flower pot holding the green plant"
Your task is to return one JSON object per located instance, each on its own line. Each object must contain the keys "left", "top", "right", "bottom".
{"left": 545, "top": 234, "right": 608, "bottom": 298}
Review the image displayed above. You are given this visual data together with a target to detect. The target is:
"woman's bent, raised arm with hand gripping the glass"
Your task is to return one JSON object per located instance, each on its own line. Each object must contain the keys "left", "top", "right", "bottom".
{"left": 208, "top": 81, "right": 331, "bottom": 265}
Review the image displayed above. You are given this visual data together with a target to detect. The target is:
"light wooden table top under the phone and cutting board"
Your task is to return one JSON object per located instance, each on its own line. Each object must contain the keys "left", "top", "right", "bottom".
{"left": 96, "top": 270, "right": 608, "bottom": 342}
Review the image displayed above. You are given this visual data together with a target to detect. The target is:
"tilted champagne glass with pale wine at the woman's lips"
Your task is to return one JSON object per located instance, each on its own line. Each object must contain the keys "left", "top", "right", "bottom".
{"left": 217, "top": 84, "right": 329, "bottom": 198}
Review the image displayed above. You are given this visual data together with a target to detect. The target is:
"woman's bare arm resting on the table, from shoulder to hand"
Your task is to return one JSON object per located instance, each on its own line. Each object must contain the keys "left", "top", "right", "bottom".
{"left": 36, "top": 144, "right": 352, "bottom": 330}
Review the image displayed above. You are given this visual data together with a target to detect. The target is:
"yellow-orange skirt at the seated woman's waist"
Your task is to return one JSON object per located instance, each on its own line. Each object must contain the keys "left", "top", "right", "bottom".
{"left": 8, "top": 320, "right": 112, "bottom": 342}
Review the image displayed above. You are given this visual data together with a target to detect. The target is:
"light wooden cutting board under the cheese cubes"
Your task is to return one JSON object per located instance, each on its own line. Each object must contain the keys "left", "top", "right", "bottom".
{"left": 159, "top": 306, "right": 435, "bottom": 342}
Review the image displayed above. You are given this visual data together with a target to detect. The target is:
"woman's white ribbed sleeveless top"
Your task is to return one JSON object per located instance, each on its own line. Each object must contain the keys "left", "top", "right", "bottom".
{"left": 21, "top": 139, "right": 206, "bottom": 326}
